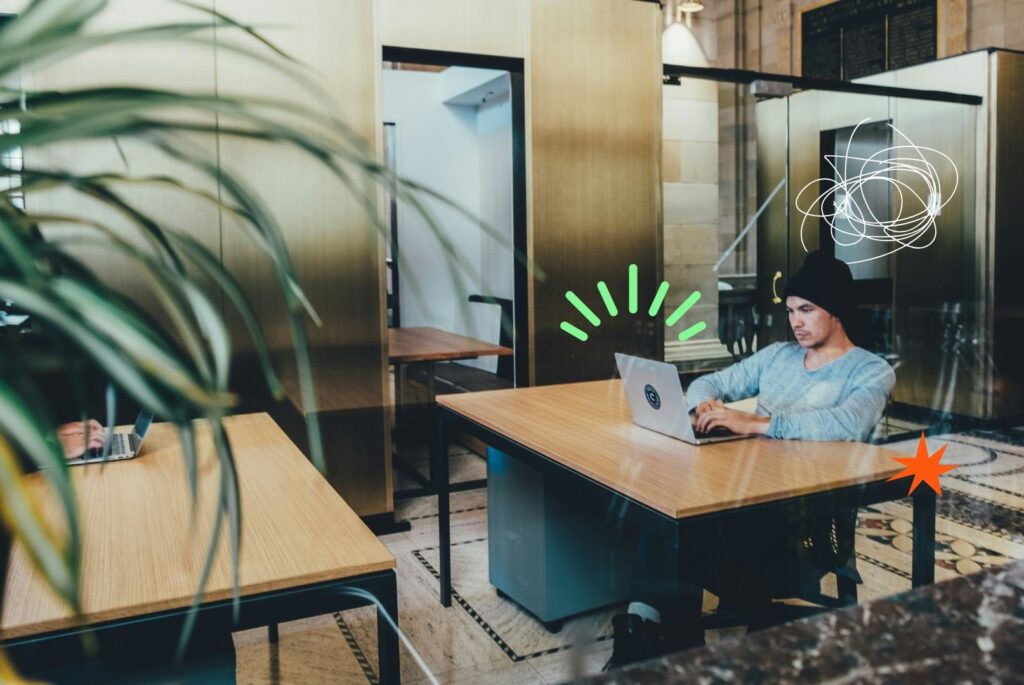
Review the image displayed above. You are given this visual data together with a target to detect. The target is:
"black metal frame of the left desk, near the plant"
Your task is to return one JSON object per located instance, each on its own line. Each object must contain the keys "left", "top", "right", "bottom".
{"left": 2, "top": 570, "right": 400, "bottom": 685}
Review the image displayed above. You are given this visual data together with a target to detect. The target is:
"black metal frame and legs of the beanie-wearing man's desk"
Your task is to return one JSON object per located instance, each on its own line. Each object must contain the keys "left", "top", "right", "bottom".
{"left": 430, "top": 405, "right": 935, "bottom": 638}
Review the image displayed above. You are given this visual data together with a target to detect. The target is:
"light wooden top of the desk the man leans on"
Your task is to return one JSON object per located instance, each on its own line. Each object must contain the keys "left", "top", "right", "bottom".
{"left": 437, "top": 381, "right": 906, "bottom": 518}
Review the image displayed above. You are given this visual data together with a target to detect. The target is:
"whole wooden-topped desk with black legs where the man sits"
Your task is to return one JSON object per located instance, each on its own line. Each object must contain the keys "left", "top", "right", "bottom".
{"left": 431, "top": 381, "right": 935, "bottom": 643}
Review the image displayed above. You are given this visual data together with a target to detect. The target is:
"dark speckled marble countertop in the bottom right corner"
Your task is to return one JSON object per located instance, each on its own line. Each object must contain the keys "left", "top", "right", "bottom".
{"left": 585, "top": 562, "right": 1024, "bottom": 685}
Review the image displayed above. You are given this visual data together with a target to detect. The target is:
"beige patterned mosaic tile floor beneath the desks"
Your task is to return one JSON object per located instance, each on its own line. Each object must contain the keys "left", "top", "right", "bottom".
{"left": 236, "top": 423, "right": 1024, "bottom": 684}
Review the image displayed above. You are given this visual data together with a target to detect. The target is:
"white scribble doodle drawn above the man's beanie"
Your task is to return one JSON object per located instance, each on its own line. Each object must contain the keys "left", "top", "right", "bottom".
{"left": 795, "top": 119, "right": 959, "bottom": 264}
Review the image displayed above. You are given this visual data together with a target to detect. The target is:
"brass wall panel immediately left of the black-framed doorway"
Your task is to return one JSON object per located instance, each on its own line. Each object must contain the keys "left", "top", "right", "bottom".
{"left": 217, "top": 0, "right": 392, "bottom": 515}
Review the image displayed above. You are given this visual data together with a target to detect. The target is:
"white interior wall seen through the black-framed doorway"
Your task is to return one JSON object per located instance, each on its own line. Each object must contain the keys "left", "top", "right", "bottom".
{"left": 382, "top": 70, "right": 513, "bottom": 371}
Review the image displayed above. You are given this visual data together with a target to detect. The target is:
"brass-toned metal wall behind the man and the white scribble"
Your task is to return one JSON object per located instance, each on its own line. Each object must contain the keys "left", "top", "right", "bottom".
{"left": 757, "top": 83, "right": 987, "bottom": 416}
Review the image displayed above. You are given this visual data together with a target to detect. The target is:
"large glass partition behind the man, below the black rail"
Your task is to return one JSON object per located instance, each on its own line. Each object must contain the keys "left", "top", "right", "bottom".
{"left": 664, "top": 70, "right": 987, "bottom": 427}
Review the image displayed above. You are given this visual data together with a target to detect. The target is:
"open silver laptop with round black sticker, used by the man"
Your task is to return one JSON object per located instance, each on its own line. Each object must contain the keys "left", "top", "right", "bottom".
{"left": 615, "top": 352, "right": 752, "bottom": 444}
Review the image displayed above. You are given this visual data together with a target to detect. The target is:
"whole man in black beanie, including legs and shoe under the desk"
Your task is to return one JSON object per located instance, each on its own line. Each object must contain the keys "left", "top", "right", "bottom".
{"left": 608, "top": 252, "right": 896, "bottom": 667}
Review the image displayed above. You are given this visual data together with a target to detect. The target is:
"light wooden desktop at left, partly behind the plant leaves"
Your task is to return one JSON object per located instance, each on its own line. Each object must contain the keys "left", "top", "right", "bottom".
{"left": 0, "top": 414, "right": 395, "bottom": 639}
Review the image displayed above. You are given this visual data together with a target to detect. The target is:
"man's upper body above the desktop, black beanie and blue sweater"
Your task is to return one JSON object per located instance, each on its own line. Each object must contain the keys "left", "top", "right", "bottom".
{"left": 687, "top": 252, "right": 896, "bottom": 440}
